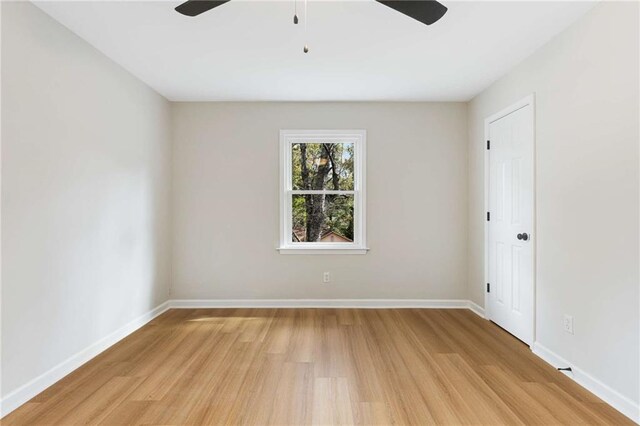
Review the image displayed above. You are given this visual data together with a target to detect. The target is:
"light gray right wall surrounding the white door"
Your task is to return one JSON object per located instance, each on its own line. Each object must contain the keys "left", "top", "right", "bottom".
{"left": 468, "top": 2, "right": 640, "bottom": 404}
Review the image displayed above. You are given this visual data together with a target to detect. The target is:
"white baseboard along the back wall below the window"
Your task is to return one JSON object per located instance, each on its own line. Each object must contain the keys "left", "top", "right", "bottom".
{"left": 169, "top": 299, "right": 469, "bottom": 309}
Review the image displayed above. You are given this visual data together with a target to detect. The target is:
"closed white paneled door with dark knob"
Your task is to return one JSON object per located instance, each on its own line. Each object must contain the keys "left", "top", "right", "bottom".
{"left": 487, "top": 103, "right": 535, "bottom": 345}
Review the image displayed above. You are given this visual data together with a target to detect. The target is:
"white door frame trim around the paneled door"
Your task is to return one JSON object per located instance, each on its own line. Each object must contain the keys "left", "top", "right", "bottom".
{"left": 482, "top": 93, "right": 538, "bottom": 347}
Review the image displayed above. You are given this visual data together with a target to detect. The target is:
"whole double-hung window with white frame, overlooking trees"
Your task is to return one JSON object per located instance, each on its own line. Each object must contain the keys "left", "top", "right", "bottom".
{"left": 279, "top": 130, "right": 367, "bottom": 254}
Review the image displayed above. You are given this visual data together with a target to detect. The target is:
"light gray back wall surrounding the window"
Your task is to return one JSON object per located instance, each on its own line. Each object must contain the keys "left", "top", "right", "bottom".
{"left": 172, "top": 103, "right": 467, "bottom": 299}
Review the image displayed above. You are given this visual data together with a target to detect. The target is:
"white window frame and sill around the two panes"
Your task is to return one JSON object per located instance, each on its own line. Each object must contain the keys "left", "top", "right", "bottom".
{"left": 278, "top": 130, "right": 369, "bottom": 254}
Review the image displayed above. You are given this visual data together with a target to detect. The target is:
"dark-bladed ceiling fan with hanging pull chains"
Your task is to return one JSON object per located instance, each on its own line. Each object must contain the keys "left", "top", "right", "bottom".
{"left": 176, "top": 0, "right": 447, "bottom": 53}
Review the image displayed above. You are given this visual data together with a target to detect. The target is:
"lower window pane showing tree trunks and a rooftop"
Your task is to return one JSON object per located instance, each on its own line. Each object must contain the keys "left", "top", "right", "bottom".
{"left": 291, "top": 194, "right": 353, "bottom": 243}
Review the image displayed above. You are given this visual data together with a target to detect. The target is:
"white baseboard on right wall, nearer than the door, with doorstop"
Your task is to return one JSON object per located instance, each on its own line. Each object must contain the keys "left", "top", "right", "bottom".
{"left": 531, "top": 342, "right": 640, "bottom": 423}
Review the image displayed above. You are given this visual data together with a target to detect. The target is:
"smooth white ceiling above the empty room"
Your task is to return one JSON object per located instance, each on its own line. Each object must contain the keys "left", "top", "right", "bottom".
{"left": 36, "top": 0, "right": 595, "bottom": 101}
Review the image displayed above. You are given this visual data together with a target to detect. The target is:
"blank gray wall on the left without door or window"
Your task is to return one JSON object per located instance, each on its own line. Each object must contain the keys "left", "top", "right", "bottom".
{"left": 1, "top": 2, "right": 171, "bottom": 396}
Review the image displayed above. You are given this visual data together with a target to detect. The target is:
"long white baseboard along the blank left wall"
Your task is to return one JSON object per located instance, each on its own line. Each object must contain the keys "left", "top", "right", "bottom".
{"left": 0, "top": 302, "right": 169, "bottom": 418}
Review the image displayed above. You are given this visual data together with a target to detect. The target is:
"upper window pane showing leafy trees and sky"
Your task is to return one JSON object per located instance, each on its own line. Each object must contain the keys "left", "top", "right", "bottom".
{"left": 291, "top": 143, "right": 354, "bottom": 191}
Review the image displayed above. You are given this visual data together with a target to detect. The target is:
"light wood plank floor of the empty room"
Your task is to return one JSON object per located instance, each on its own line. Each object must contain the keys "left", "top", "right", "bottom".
{"left": 2, "top": 309, "right": 632, "bottom": 425}
